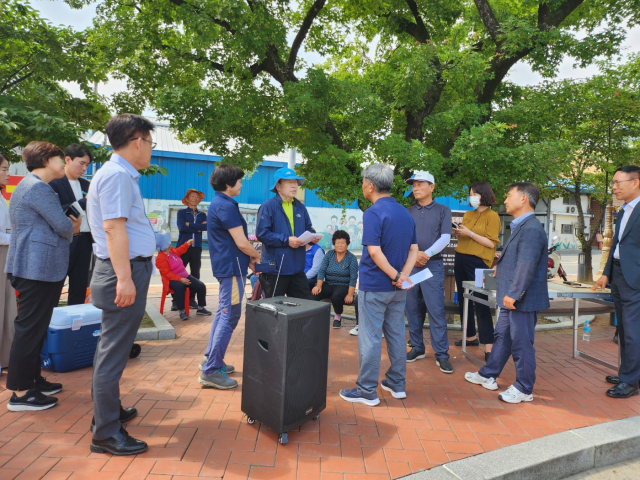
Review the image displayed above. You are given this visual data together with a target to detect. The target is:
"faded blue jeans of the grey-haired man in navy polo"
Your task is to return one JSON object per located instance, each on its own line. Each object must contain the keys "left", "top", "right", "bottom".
{"left": 356, "top": 290, "right": 407, "bottom": 400}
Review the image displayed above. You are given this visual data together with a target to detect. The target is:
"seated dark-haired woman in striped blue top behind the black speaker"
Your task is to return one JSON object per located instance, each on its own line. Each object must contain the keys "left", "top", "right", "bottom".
{"left": 311, "top": 230, "right": 358, "bottom": 328}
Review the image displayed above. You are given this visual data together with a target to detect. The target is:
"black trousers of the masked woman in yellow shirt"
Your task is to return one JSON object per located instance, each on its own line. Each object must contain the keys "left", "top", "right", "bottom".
{"left": 454, "top": 252, "right": 493, "bottom": 345}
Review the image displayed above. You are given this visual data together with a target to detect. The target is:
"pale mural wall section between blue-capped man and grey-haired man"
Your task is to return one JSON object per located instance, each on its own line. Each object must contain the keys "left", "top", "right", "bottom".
{"left": 308, "top": 207, "right": 362, "bottom": 250}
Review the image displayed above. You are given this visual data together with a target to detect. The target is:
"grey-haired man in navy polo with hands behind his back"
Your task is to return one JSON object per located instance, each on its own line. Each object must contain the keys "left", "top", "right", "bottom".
{"left": 340, "top": 164, "right": 418, "bottom": 406}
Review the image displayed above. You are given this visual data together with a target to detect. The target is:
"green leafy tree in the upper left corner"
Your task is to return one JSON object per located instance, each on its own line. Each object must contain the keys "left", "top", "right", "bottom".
{"left": 0, "top": 0, "right": 109, "bottom": 160}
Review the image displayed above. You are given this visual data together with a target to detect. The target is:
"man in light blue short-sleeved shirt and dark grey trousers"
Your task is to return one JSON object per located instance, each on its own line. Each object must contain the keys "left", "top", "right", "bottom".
{"left": 87, "top": 113, "right": 156, "bottom": 455}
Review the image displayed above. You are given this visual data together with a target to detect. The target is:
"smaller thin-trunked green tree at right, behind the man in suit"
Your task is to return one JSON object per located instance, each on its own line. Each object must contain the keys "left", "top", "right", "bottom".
{"left": 496, "top": 55, "right": 640, "bottom": 281}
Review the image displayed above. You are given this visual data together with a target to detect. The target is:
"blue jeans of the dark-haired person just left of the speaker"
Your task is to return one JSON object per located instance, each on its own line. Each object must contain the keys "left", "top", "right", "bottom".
{"left": 202, "top": 277, "right": 246, "bottom": 374}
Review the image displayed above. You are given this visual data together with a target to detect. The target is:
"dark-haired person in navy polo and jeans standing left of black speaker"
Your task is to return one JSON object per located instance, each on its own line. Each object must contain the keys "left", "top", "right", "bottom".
{"left": 198, "top": 164, "right": 260, "bottom": 390}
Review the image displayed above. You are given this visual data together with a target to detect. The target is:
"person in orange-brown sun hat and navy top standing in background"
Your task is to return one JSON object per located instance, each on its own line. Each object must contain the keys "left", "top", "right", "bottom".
{"left": 171, "top": 188, "right": 207, "bottom": 311}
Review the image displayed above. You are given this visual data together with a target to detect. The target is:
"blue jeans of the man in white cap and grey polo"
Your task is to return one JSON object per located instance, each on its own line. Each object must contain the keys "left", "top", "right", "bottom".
{"left": 406, "top": 260, "right": 449, "bottom": 359}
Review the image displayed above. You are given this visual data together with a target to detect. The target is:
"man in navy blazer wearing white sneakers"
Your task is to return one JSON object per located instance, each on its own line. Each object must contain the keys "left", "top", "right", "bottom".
{"left": 464, "top": 183, "right": 549, "bottom": 403}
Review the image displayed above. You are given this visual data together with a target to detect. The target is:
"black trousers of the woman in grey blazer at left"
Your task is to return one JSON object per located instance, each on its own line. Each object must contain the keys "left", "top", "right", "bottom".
{"left": 7, "top": 277, "right": 64, "bottom": 390}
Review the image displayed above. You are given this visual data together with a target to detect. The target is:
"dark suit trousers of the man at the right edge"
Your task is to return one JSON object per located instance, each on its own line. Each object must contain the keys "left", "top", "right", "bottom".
{"left": 608, "top": 263, "right": 640, "bottom": 385}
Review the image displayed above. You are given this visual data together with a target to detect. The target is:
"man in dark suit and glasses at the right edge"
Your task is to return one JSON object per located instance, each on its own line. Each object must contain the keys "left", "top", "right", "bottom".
{"left": 591, "top": 165, "right": 640, "bottom": 398}
